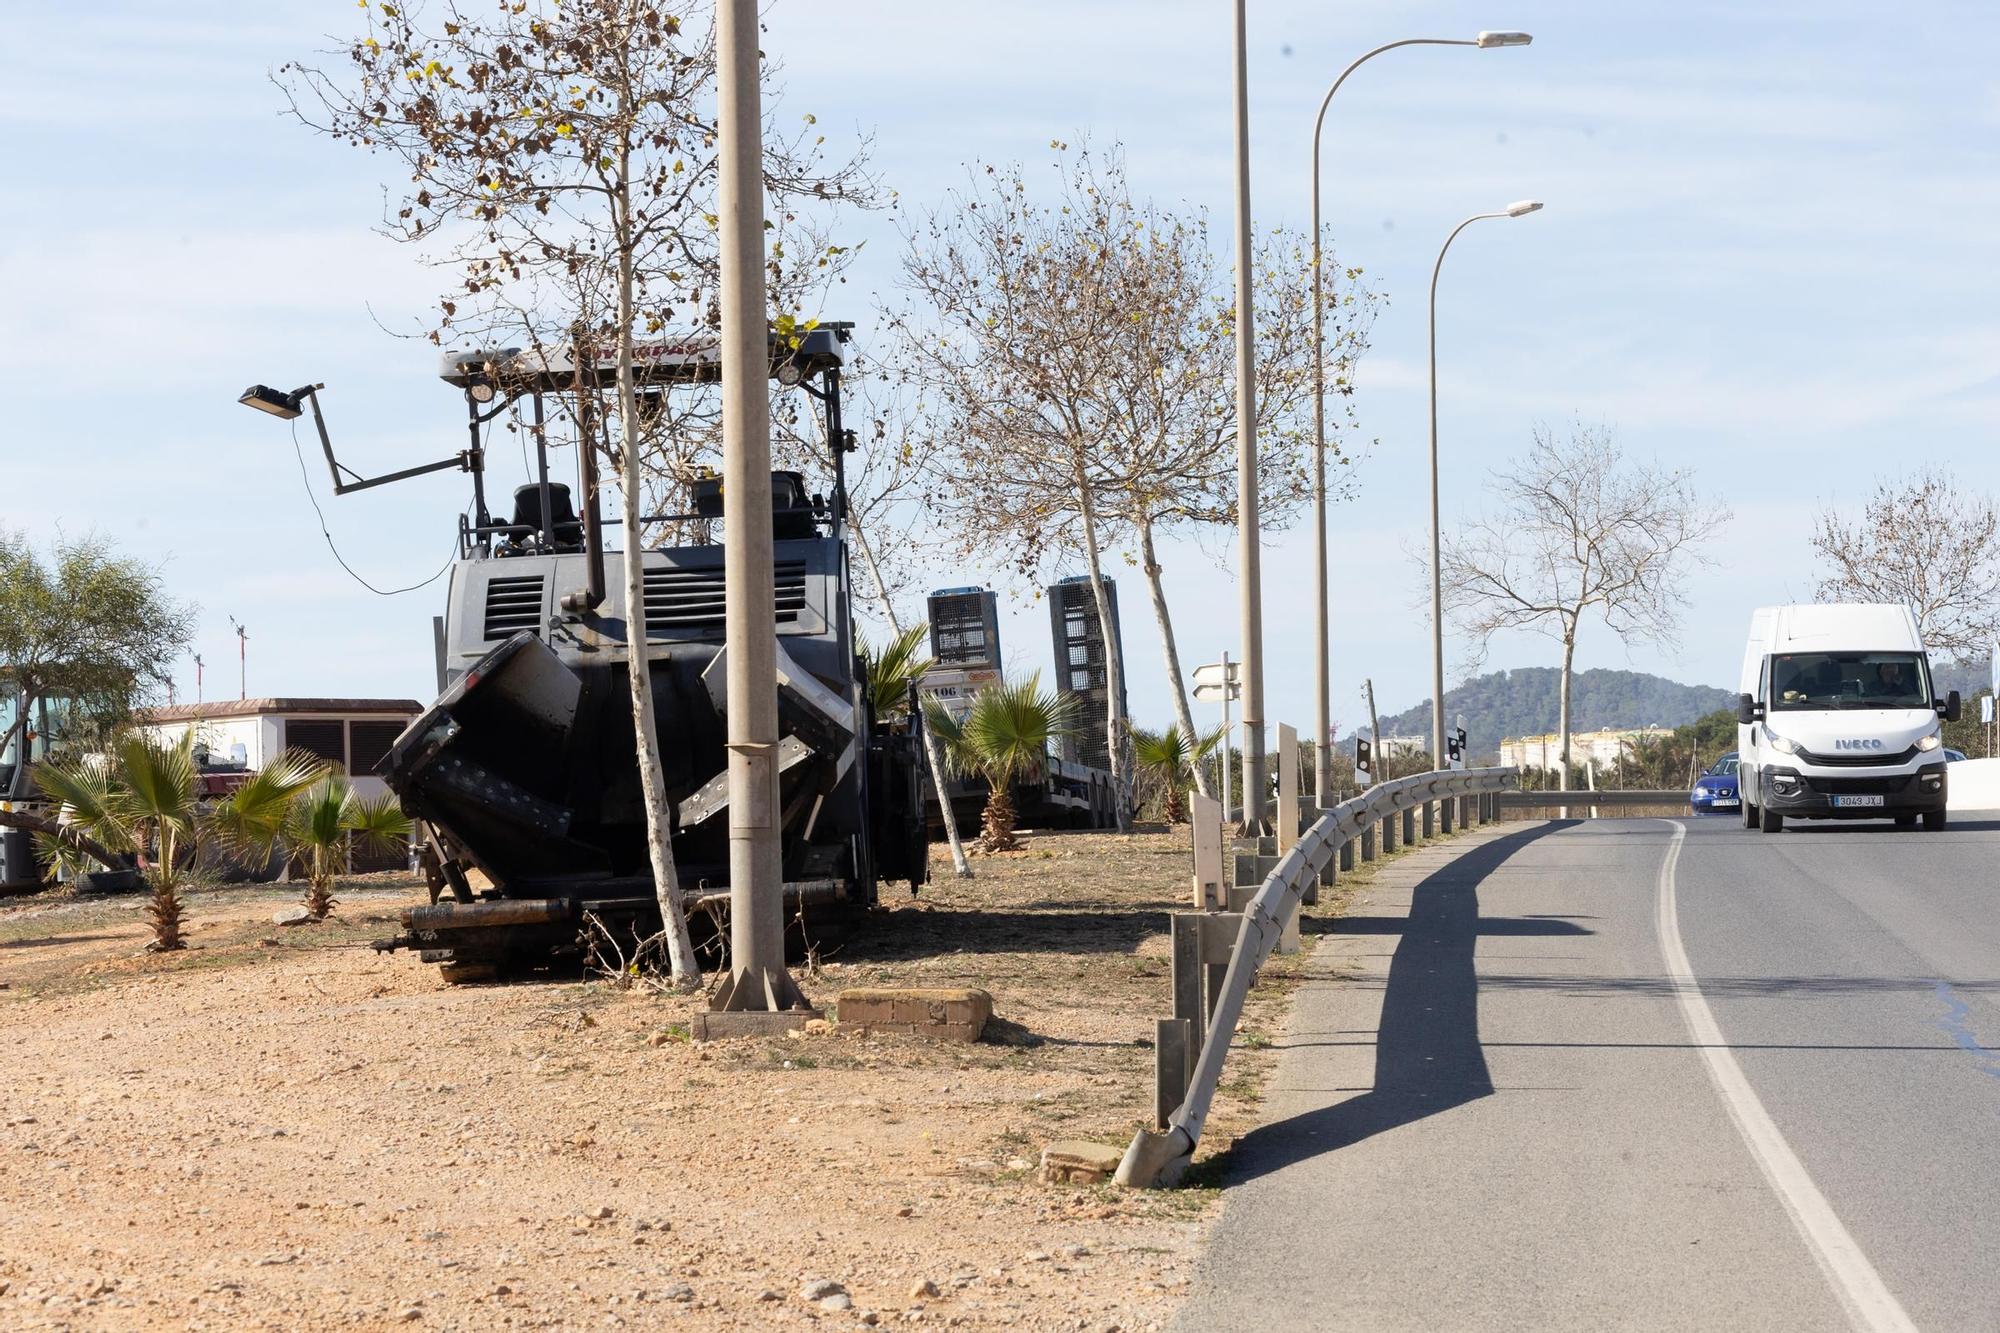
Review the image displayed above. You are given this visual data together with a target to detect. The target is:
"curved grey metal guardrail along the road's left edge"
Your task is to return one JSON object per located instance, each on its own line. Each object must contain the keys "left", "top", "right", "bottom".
{"left": 1116, "top": 769, "right": 1520, "bottom": 1189}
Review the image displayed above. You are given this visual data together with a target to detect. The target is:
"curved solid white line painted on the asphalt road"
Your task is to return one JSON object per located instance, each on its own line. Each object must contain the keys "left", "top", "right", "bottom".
{"left": 1658, "top": 819, "right": 1916, "bottom": 1333}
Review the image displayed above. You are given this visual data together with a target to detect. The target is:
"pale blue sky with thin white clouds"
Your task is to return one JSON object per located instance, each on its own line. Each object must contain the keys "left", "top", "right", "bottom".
{"left": 0, "top": 0, "right": 2000, "bottom": 735}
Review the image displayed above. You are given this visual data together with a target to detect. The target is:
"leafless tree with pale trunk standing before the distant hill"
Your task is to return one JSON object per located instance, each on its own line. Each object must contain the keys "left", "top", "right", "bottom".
{"left": 1442, "top": 422, "right": 1730, "bottom": 787}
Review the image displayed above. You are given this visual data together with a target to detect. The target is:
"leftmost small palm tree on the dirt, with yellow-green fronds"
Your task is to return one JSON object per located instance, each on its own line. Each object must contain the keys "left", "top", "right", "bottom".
{"left": 34, "top": 733, "right": 322, "bottom": 951}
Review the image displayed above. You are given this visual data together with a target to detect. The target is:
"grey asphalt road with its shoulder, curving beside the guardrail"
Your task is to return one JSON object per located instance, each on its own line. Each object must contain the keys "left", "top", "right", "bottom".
{"left": 1178, "top": 817, "right": 2000, "bottom": 1333}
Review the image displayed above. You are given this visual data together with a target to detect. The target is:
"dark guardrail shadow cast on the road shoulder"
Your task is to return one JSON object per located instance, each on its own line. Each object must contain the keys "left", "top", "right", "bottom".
{"left": 1226, "top": 823, "right": 1590, "bottom": 1183}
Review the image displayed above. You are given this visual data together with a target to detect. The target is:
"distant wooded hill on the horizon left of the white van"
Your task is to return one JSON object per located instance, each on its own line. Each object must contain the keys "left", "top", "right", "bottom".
{"left": 1382, "top": 667, "right": 1736, "bottom": 757}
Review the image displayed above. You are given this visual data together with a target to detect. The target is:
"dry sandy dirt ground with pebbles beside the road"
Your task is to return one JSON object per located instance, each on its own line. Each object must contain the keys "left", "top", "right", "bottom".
{"left": 0, "top": 829, "right": 1456, "bottom": 1331}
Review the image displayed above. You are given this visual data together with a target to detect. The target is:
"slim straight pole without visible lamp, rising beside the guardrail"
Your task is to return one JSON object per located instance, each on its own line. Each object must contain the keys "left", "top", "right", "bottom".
{"left": 1236, "top": 0, "right": 1268, "bottom": 831}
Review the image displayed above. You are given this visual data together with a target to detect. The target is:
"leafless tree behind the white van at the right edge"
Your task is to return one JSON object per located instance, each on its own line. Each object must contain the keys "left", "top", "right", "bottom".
{"left": 1812, "top": 468, "right": 2000, "bottom": 656}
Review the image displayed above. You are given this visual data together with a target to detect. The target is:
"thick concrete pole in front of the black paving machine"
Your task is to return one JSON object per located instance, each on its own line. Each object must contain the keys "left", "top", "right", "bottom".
{"left": 712, "top": 0, "right": 804, "bottom": 1009}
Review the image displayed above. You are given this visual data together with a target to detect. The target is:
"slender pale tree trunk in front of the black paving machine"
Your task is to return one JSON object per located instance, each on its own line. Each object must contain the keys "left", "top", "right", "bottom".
{"left": 608, "top": 169, "right": 702, "bottom": 991}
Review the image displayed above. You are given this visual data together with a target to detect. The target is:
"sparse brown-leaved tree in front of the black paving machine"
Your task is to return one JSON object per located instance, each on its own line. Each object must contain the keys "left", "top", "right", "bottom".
{"left": 282, "top": 0, "right": 868, "bottom": 987}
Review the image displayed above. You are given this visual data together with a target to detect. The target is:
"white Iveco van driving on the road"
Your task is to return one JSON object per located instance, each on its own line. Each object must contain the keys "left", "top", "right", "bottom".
{"left": 1736, "top": 602, "right": 1958, "bottom": 833}
